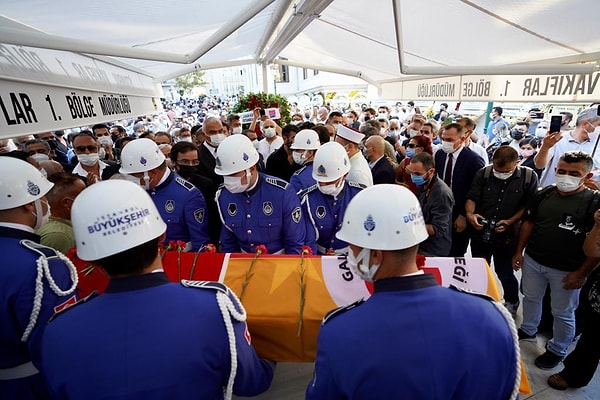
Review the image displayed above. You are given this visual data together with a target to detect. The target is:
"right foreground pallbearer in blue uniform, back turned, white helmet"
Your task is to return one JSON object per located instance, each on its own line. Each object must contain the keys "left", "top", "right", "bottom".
{"left": 306, "top": 185, "right": 520, "bottom": 400}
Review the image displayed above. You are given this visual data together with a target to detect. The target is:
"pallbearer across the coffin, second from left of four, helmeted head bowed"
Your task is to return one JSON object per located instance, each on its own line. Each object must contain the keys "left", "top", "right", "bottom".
{"left": 215, "top": 135, "right": 305, "bottom": 254}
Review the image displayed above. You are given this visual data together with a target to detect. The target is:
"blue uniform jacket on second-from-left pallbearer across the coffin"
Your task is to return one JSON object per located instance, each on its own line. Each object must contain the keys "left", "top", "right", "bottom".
{"left": 216, "top": 173, "right": 305, "bottom": 254}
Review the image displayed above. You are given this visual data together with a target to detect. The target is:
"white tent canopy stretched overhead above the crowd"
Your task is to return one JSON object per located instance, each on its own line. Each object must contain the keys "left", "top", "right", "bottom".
{"left": 0, "top": 0, "right": 600, "bottom": 136}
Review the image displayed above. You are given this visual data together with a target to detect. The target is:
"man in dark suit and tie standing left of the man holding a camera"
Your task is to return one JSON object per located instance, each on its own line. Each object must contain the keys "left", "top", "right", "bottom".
{"left": 435, "top": 123, "right": 485, "bottom": 257}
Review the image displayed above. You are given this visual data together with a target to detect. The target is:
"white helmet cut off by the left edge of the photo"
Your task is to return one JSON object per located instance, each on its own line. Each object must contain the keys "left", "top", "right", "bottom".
{"left": 0, "top": 156, "right": 54, "bottom": 210}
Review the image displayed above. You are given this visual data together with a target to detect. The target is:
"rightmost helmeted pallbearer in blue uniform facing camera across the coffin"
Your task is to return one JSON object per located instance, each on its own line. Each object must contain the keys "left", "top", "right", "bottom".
{"left": 298, "top": 142, "right": 366, "bottom": 255}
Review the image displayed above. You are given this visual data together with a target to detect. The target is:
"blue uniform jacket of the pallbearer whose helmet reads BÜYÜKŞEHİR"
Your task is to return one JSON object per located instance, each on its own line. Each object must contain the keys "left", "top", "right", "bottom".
{"left": 42, "top": 272, "right": 273, "bottom": 400}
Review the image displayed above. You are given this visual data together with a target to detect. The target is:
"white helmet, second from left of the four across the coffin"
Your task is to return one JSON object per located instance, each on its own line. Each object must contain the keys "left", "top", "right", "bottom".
{"left": 215, "top": 135, "right": 259, "bottom": 175}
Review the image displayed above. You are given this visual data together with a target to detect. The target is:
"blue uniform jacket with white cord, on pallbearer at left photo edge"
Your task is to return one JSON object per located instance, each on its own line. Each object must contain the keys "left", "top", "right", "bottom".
{"left": 0, "top": 227, "right": 77, "bottom": 400}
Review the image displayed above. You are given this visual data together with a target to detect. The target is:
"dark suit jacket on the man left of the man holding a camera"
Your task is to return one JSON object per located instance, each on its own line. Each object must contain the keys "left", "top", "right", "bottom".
{"left": 434, "top": 147, "right": 485, "bottom": 220}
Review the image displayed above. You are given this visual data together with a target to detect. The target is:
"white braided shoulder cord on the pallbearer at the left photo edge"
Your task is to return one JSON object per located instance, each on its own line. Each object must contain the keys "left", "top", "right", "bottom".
{"left": 21, "top": 240, "right": 79, "bottom": 342}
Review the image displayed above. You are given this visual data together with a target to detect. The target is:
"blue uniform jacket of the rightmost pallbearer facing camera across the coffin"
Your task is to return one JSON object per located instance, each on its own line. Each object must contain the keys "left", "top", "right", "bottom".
{"left": 300, "top": 181, "right": 366, "bottom": 255}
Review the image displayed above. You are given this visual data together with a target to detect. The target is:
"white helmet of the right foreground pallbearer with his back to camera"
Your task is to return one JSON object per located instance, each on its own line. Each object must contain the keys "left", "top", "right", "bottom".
{"left": 336, "top": 184, "right": 429, "bottom": 250}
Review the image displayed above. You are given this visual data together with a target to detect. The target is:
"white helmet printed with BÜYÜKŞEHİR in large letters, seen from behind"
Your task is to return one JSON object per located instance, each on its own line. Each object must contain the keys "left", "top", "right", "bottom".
{"left": 71, "top": 180, "right": 167, "bottom": 261}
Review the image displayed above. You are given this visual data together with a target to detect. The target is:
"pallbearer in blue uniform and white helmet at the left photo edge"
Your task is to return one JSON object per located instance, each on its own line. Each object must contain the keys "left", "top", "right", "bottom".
{"left": 0, "top": 157, "right": 77, "bottom": 400}
